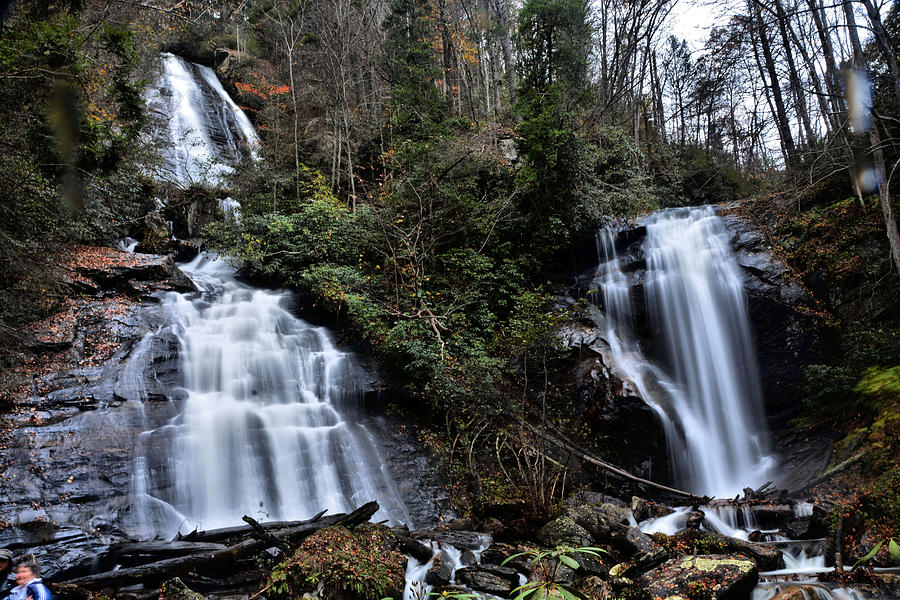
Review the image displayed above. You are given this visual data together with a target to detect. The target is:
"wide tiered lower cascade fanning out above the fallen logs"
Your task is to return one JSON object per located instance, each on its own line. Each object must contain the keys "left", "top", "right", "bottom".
{"left": 134, "top": 258, "right": 410, "bottom": 537}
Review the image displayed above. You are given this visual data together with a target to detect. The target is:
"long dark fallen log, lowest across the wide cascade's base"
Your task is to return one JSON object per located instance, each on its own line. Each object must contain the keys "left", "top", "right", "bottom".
{"left": 63, "top": 502, "right": 378, "bottom": 589}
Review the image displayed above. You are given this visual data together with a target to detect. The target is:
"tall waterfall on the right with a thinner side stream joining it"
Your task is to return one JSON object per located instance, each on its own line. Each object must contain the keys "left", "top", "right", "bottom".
{"left": 594, "top": 207, "right": 773, "bottom": 497}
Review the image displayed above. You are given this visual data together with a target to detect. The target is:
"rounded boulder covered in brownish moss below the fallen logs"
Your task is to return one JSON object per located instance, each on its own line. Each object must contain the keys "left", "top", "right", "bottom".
{"left": 269, "top": 523, "right": 407, "bottom": 600}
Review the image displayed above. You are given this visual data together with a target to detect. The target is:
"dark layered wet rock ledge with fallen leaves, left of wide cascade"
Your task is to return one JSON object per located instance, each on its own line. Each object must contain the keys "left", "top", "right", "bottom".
{"left": 0, "top": 246, "right": 196, "bottom": 576}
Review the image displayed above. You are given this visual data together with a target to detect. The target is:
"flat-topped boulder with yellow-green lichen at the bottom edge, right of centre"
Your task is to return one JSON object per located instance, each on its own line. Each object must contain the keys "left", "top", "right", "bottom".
{"left": 639, "top": 554, "right": 759, "bottom": 600}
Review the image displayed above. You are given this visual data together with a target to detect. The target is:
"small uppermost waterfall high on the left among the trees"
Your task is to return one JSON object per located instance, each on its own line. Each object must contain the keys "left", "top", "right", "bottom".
{"left": 146, "top": 54, "right": 259, "bottom": 187}
